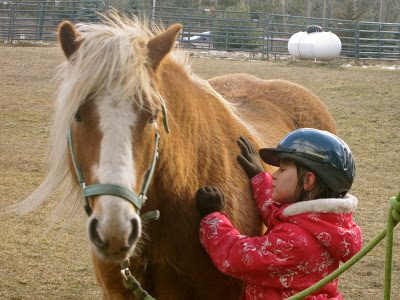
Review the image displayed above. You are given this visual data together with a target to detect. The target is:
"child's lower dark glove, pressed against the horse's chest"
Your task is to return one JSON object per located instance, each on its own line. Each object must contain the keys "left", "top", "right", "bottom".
{"left": 196, "top": 186, "right": 224, "bottom": 218}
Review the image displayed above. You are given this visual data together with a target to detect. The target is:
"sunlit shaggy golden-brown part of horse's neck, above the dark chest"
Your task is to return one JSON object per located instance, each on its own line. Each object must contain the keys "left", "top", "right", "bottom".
{"left": 152, "top": 61, "right": 249, "bottom": 203}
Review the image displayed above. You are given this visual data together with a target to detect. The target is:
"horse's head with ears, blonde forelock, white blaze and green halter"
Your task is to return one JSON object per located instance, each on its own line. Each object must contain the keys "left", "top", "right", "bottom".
{"left": 57, "top": 19, "right": 181, "bottom": 262}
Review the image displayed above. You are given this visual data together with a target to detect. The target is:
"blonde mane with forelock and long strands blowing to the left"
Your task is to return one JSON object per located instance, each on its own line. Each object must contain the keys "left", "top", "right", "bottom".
{"left": 9, "top": 12, "right": 169, "bottom": 219}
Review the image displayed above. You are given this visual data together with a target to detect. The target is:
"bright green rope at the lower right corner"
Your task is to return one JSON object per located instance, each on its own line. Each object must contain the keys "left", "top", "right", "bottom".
{"left": 287, "top": 193, "right": 400, "bottom": 300}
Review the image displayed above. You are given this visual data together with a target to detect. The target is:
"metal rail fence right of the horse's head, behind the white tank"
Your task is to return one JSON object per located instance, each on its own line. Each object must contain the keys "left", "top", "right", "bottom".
{"left": 150, "top": 7, "right": 400, "bottom": 61}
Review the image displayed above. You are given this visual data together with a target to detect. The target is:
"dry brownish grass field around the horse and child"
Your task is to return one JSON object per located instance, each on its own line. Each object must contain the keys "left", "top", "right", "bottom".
{"left": 0, "top": 45, "right": 400, "bottom": 299}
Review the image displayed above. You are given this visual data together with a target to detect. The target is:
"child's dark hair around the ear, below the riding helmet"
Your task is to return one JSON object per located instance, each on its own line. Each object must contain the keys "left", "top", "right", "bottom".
{"left": 289, "top": 159, "right": 346, "bottom": 201}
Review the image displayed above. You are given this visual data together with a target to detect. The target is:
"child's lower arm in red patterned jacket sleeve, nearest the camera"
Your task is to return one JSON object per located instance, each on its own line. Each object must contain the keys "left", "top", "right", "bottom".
{"left": 200, "top": 212, "right": 310, "bottom": 286}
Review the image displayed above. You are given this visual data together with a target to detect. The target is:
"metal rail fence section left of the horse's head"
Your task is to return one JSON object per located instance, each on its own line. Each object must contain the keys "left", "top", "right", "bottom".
{"left": 0, "top": 0, "right": 105, "bottom": 42}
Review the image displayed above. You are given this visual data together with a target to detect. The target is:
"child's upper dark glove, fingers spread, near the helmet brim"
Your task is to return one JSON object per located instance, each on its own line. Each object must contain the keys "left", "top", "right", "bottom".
{"left": 236, "top": 136, "right": 264, "bottom": 179}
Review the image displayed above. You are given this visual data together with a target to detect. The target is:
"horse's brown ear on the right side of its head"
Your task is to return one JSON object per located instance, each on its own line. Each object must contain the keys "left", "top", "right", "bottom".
{"left": 147, "top": 24, "right": 182, "bottom": 70}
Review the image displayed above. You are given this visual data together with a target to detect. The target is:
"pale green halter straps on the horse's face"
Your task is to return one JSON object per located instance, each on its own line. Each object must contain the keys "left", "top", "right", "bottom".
{"left": 67, "top": 105, "right": 169, "bottom": 220}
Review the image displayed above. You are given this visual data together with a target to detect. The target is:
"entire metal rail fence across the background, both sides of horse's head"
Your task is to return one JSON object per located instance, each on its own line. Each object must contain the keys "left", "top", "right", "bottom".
{"left": 0, "top": 0, "right": 400, "bottom": 61}
